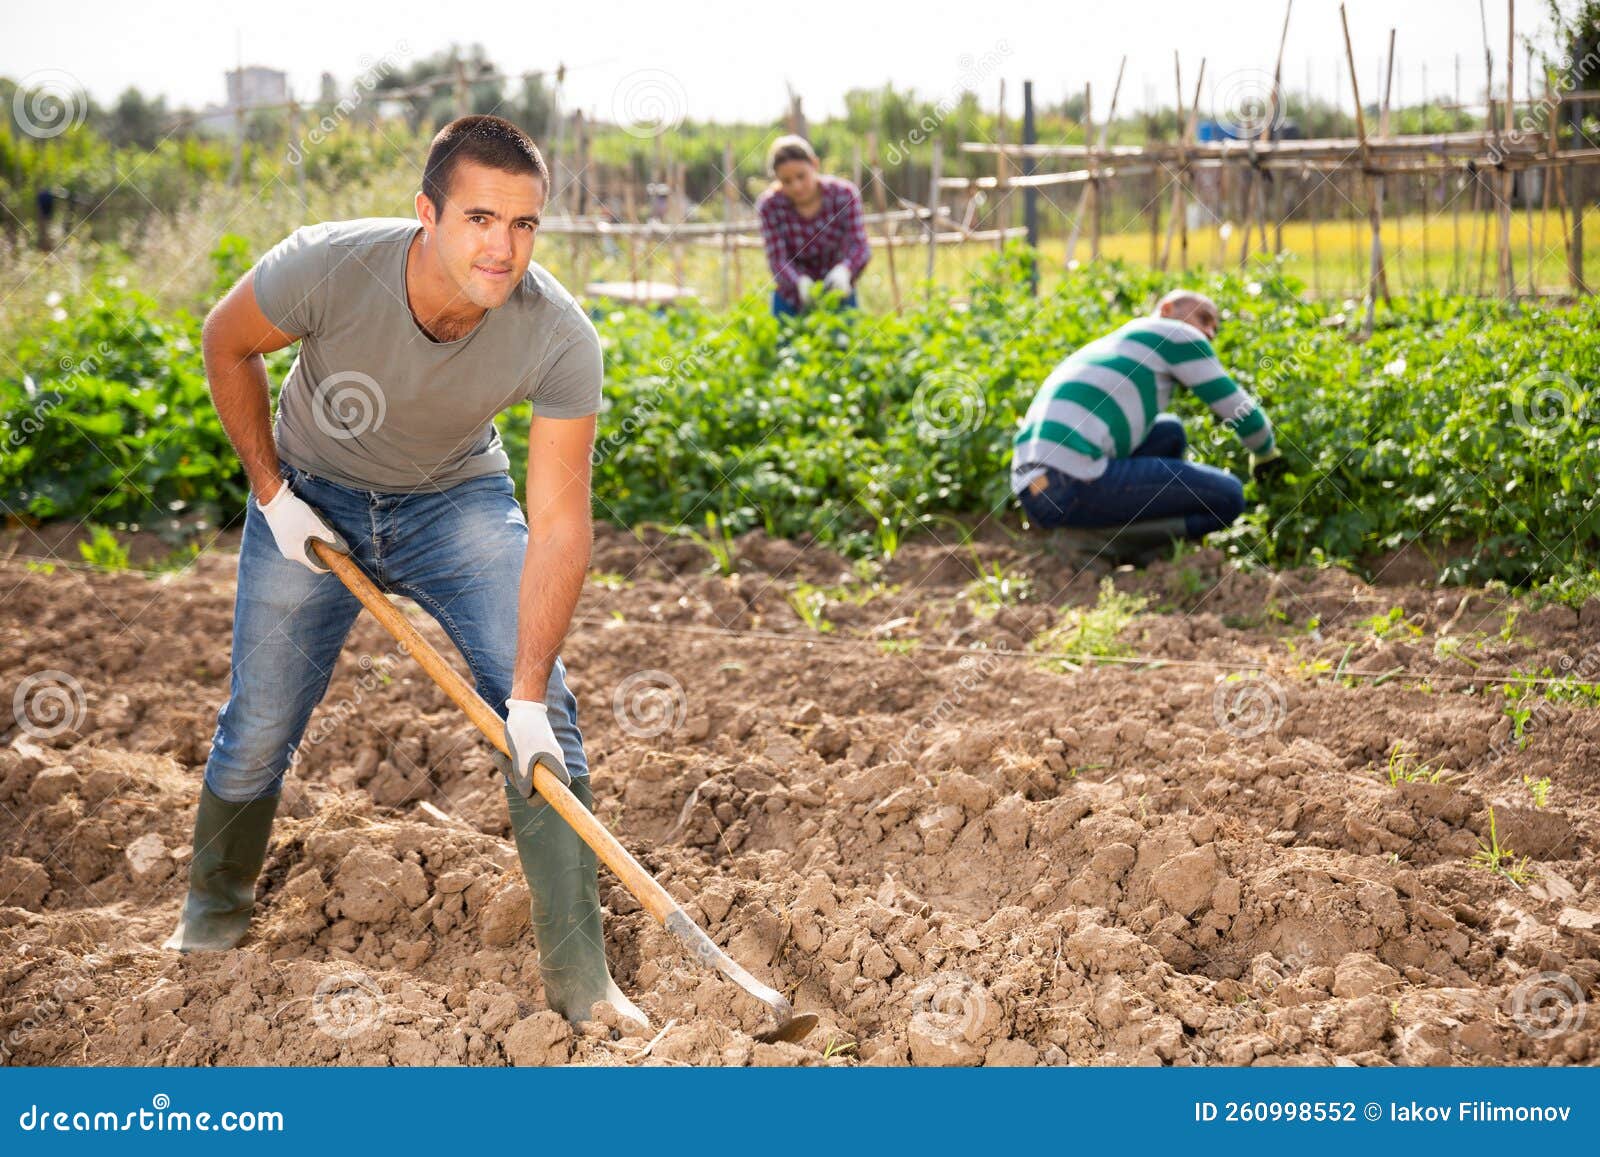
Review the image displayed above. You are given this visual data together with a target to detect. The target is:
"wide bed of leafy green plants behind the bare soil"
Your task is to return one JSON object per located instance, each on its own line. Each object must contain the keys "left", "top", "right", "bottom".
{"left": 0, "top": 245, "right": 1600, "bottom": 589}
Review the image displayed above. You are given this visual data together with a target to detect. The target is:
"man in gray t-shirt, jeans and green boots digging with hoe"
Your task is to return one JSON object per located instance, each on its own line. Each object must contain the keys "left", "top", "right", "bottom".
{"left": 157, "top": 117, "right": 645, "bottom": 1026}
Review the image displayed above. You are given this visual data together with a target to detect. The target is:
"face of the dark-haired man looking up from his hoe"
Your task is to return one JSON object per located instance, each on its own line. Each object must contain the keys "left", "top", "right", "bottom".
{"left": 419, "top": 162, "right": 546, "bottom": 309}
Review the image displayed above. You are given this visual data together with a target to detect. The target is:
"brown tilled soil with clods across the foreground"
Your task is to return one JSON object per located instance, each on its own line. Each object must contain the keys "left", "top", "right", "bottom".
{"left": 0, "top": 528, "right": 1600, "bottom": 1064}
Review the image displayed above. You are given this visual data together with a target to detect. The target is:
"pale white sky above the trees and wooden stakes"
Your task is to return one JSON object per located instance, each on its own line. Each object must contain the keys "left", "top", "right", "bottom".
{"left": 0, "top": 0, "right": 1547, "bottom": 122}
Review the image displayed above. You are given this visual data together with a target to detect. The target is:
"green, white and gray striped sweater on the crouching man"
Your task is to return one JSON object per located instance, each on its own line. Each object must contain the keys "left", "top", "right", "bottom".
{"left": 1011, "top": 317, "right": 1272, "bottom": 494}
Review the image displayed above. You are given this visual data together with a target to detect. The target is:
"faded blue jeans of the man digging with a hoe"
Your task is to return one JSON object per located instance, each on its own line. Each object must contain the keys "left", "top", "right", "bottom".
{"left": 205, "top": 464, "right": 589, "bottom": 803}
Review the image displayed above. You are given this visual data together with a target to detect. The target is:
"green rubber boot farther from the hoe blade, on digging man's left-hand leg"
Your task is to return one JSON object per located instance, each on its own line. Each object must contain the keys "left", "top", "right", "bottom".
{"left": 163, "top": 786, "right": 278, "bottom": 952}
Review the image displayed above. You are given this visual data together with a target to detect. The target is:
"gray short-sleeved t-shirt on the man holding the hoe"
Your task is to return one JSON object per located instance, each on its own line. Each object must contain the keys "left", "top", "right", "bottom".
{"left": 254, "top": 218, "right": 602, "bottom": 493}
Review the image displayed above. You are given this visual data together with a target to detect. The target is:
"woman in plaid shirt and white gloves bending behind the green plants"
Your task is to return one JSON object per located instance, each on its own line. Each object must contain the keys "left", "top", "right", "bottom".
{"left": 755, "top": 136, "right": 872, "bottom": 317}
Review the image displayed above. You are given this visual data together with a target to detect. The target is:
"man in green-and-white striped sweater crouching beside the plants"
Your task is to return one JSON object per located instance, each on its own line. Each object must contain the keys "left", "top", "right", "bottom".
{"left": 1011, "top": 290, "right": 1283, "bottom": 565}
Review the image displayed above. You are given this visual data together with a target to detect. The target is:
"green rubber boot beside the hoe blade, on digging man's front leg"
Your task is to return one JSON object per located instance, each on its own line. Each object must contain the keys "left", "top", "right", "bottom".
{"left": 506, "top": 776, "right": 650, "bottom": 1031}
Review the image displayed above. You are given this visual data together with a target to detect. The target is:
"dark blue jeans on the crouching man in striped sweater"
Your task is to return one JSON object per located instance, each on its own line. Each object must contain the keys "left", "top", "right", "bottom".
{"left": 1019, "top": 414, "right": 1245, "bottom": 539}
